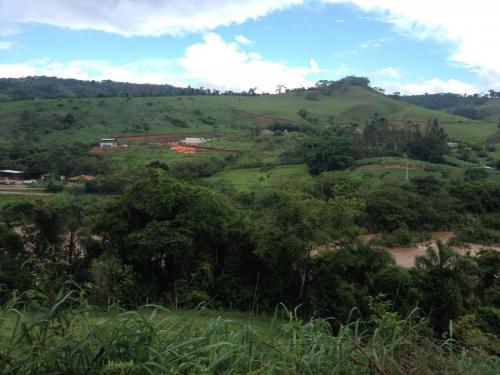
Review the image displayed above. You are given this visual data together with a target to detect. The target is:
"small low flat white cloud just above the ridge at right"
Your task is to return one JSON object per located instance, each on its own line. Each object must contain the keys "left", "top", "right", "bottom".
{"left": 374, "top": 78, "right": 477, "bottom": 95}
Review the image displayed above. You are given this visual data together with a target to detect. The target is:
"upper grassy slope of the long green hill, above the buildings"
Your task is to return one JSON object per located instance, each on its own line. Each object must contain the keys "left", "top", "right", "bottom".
{"left": 0, "top": 86, "right": 497, "bottom": 148}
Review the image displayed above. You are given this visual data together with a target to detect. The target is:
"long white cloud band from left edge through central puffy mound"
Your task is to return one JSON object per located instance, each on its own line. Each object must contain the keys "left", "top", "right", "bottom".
{"left": 0, "top": 33, "right": 319, "bottom": 92}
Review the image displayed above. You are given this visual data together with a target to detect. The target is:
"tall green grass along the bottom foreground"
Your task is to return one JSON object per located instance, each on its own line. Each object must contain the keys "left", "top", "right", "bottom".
{"left": 0, "top": 290, "right": 500, "bottom": 375}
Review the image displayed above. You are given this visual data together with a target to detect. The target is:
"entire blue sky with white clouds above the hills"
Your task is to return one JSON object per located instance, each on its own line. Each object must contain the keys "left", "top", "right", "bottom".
{"left": 0, "top": 0, "right": 500, "bottom": 94}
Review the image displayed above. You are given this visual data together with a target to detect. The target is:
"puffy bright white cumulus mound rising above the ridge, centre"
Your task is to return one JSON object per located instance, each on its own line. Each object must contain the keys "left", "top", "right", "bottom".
{"left": 180, "top": 33, "right": 313, "bottom": 92}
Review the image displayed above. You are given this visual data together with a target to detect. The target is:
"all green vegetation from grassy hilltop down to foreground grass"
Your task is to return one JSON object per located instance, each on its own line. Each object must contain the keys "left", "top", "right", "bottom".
{"left": 0, "top": 77, "right": 500, "bottom": 374}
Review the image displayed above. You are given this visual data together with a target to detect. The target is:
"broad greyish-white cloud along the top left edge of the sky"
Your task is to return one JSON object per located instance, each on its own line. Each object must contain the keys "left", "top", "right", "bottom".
{"left": 0, "top": 0, "right": 303, "bottom": 36}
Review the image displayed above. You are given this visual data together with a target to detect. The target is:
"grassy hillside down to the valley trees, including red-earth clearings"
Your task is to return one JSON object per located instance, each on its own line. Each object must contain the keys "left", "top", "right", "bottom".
{"left": 0, "top": 84, "right": 498, "bottom": 176}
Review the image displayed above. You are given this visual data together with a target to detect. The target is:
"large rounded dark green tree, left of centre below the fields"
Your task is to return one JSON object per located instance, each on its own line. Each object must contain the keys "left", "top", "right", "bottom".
{"left": 97, "top": 169, "right": 248, "bottom": 302}
